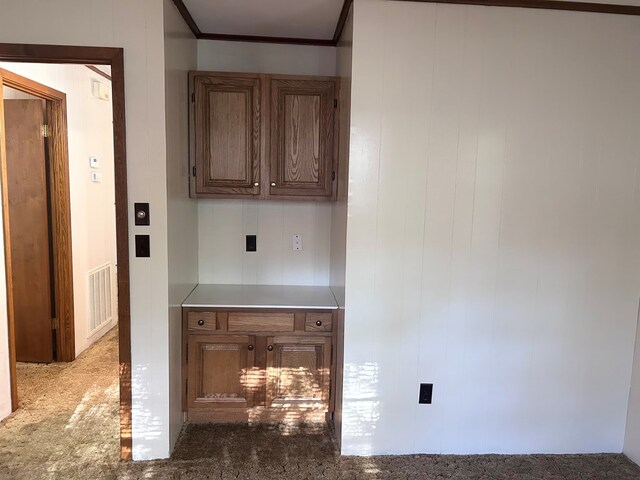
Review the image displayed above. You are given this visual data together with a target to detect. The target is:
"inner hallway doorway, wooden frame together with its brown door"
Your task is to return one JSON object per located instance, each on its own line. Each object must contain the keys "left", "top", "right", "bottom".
{"left": 0, "top": 72, "right": 75, "bottom": 364}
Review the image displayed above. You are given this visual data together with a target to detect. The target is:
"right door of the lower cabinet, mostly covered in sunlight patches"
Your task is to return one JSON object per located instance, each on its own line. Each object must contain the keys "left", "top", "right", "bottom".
{"left": 266, "top": 336, "right": 331, "bottom": 410}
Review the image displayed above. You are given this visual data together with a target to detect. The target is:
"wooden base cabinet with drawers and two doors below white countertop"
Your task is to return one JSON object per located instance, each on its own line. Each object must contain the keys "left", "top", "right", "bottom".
{"left": 183, "top": 308, "right": 336, "bottom": 421}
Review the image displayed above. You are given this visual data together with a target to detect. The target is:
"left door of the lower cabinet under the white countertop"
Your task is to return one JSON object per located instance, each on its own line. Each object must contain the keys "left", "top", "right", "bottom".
{"left": 187, "top": 335, "right": 262, "bottom": 410}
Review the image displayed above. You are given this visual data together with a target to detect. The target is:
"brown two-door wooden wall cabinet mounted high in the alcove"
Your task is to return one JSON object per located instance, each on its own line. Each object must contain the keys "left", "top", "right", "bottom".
{"left": 189, "top": 72, "right": 339, "bottom": 200}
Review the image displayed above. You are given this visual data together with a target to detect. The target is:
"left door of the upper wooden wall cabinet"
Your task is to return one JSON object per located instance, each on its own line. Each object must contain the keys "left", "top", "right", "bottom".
{"left": 192, "top": 75, "right": 261, "bottom": 197}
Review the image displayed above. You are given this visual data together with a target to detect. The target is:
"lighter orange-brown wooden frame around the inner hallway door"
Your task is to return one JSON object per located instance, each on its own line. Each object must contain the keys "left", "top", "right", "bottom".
{"left": 0, "top": 68, "right": 76, "bottom": 366}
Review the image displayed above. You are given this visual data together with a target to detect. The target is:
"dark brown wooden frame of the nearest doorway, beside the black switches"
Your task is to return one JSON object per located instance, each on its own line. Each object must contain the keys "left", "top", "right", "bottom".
{"left": 0, "top": 43, "right": 132, "bottom": 460}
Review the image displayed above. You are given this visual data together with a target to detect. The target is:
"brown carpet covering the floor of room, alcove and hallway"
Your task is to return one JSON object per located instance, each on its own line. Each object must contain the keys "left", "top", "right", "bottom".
{"left": 0, "top": 329, "right": 640, "bottom": 480}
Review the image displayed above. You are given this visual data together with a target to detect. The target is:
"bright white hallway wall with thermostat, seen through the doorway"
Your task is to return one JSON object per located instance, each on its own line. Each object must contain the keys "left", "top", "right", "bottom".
{"left": 0, "top": 62, "right": 118, "bottom": 355}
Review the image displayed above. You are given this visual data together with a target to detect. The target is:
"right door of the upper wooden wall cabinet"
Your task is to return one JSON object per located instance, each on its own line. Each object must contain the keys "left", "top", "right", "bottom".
{"left": 269, "top": 77, "right": 336, "bottom": 198}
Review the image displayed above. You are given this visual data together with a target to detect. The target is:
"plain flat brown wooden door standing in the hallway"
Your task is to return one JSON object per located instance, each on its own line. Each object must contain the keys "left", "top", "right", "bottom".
{"left": 4, "top": 100, "right": 53, "bottom": 362}
